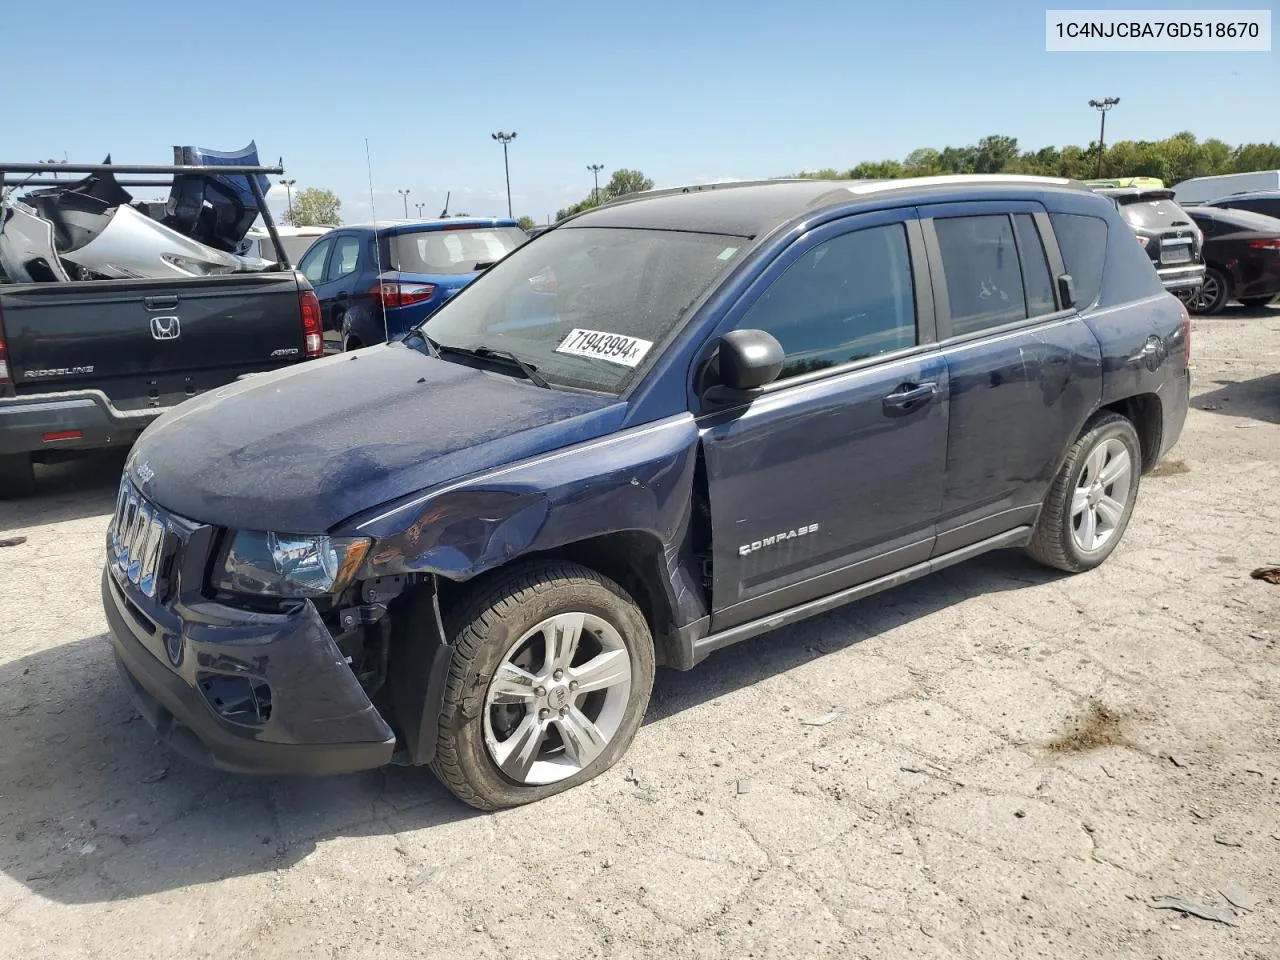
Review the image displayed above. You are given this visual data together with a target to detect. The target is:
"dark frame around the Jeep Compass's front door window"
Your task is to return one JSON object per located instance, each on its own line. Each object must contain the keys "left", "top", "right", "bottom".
{"left": 690, "top": 206, "right": 938, "bottom": 413}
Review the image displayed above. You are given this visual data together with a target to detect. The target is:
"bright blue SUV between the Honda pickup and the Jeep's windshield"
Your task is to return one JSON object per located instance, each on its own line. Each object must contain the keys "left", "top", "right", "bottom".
{"left": 298, "top": 216, "right": 529, "bottom": 351}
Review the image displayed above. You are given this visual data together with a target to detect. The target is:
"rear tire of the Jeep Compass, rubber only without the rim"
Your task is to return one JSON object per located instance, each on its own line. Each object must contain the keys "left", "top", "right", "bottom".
{"left": 1027, "top": 411, "right": 1142, "bottom": 573}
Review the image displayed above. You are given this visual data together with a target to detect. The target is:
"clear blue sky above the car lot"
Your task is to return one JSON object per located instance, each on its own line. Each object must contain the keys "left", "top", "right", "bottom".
{"left": 0, "top": 0, "right": 1280, "bottom": 221}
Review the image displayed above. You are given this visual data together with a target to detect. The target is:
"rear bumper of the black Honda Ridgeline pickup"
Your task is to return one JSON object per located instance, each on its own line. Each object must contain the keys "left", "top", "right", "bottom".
{"left": 0, "top": 390, "right": 168, "bottom": 453}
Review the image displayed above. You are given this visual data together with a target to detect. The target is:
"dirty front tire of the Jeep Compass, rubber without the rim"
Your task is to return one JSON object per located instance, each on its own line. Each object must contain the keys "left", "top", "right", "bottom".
{"left": 431, "top": 562, "right": 654, "bottom": 810}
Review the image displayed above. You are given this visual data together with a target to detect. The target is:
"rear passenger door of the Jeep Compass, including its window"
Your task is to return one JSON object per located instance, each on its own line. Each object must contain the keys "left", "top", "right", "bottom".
{"left": 920, "top": 201, "right": 1101, "bottom": 554}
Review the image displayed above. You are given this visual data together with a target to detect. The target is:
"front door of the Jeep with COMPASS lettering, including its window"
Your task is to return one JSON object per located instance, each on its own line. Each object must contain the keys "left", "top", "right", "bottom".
{"left": 700, "top": 210, "right": 947, "bottom": 631}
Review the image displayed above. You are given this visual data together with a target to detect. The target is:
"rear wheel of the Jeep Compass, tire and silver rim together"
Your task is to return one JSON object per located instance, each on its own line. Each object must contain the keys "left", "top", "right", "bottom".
{"left": 1027, "top": 413, "right": 1142, "bottom": 573}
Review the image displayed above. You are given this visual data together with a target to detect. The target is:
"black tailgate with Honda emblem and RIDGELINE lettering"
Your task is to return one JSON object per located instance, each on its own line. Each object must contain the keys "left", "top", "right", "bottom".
{"left": 3, "top": 273, "right": 305, "bottom": 410}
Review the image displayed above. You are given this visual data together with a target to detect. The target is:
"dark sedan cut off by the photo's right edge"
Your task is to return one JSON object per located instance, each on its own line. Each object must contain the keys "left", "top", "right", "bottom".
{"left": 1187, "top": 206, "right": 1280, "bottom": 314}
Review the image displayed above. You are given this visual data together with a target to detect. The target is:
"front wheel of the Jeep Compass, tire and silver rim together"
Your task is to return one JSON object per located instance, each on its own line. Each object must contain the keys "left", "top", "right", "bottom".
{"left": 431, "top": 563, "right": 654, "bottom": 810}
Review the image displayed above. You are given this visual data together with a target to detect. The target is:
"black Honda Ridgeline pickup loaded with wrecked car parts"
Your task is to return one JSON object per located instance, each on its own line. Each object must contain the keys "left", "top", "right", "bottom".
{"left": 0, "top": 148, "right": 324, "bottom": 497}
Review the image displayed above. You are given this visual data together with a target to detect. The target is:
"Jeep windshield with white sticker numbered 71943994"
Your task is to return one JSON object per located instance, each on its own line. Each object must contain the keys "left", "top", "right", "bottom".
{"left": 406, "top": 227, "right": 748, "bottom": 393}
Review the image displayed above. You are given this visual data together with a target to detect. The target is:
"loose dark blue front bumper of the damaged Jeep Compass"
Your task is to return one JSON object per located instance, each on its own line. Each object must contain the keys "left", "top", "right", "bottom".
{"left": 102, "top": 566, "right": 396, "bottom": 774}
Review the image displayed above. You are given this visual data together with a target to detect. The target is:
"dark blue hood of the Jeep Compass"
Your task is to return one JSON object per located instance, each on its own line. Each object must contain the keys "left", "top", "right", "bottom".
{"left": 127, "top": 344, "right": 626, "bottom": 534}
